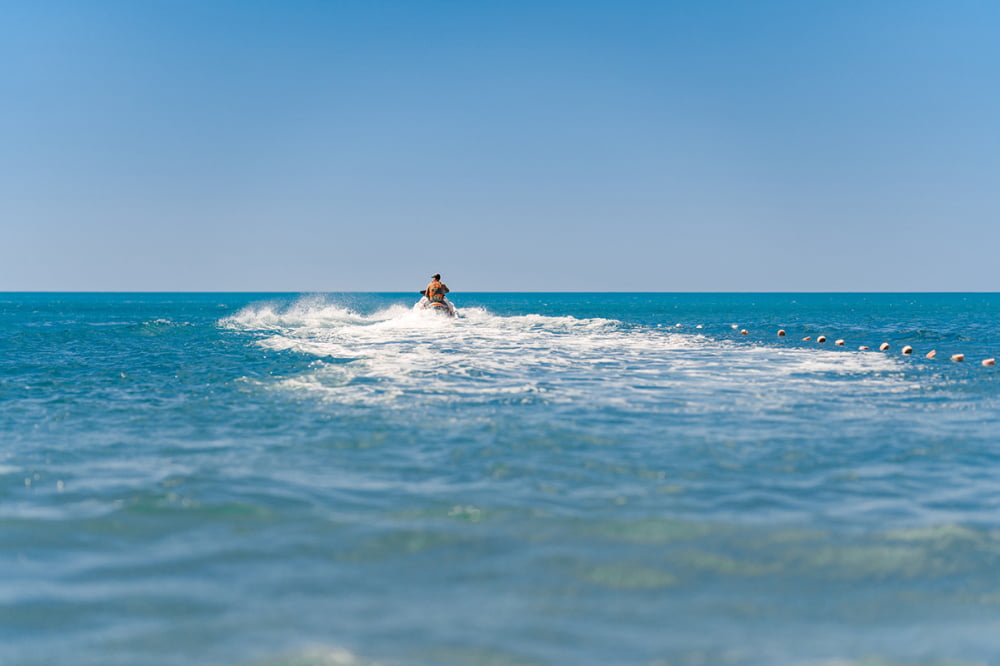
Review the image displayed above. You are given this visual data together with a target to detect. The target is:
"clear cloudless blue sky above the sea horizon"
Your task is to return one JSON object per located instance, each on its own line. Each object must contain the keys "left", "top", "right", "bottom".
{"left": 0, "top": 0, "right": 1000, "bottom": 293}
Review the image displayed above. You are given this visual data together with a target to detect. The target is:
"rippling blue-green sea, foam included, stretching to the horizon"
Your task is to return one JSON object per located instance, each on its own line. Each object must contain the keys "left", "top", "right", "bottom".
{"left": 0, "top": 293, "right": 1000, "bottom": 666}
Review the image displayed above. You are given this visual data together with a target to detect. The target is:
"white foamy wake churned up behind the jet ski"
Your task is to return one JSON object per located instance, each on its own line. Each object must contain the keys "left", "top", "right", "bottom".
{"left": 221, "top": 298, "right": 906, "bottom": 408}
